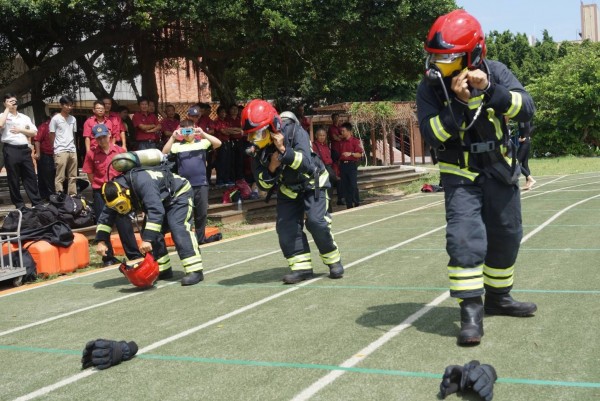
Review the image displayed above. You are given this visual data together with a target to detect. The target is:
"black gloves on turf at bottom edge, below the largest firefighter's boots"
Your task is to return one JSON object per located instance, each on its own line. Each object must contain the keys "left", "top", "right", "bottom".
{"left": 440, "top": 361, "right": 498, "bottom": 401}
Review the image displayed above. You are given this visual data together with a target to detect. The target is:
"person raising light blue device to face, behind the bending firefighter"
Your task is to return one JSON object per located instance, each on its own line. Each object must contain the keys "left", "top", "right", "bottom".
{"left": 163, "top": 120, "right": 221, "bottom": 244}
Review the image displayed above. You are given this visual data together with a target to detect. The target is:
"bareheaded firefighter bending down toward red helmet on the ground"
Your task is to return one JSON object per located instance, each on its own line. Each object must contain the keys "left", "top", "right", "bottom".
{"left": 96, "top": 166, "right": 204, "bottom": 285}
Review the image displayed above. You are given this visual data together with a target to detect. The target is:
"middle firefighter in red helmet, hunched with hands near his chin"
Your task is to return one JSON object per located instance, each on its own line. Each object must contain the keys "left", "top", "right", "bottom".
{"left": 242, "top": 99, "right": 344, "bottom": 284}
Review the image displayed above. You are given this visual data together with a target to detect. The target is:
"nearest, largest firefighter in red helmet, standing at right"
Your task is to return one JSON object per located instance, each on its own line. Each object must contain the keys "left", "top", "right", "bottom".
{"left": 417, "top": 10, "right": 537, "bottom": 345}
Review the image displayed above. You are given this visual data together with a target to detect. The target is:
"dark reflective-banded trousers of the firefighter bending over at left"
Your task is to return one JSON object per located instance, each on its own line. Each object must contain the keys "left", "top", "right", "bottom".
{"left": 152, "top": 188, "right": 202, "bottom": 273}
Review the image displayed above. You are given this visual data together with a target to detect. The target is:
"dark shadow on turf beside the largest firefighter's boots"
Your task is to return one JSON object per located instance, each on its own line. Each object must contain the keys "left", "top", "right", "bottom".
{"left": 356, "top": 302, "right": 460, "bottom": 337}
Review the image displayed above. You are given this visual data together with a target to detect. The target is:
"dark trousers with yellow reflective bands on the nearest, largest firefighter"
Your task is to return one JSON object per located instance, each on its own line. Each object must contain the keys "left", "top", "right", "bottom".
{"left": 441, "top": 174, "right": 523, "bottom": 298}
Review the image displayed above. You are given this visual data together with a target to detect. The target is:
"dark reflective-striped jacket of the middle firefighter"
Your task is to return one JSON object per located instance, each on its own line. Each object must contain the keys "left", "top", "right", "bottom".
{"left": 254, "top": 119, "right": 330, "bottom": 199}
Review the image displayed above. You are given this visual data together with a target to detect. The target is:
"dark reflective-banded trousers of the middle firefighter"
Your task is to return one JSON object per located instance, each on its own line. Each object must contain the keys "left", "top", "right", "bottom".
{"left": 276, "top": 189, "right": 340, "bottom": 270}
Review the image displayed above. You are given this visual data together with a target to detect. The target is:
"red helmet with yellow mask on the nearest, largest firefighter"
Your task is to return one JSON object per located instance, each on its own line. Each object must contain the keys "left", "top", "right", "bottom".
{"left": 425, "top": 9, "right": 486, "bottom": 77}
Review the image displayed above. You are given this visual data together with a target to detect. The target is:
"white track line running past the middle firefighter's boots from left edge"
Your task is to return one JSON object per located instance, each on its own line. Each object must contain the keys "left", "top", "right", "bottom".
{"left": 0, "top": 201, "right": 442, "bottom": 337}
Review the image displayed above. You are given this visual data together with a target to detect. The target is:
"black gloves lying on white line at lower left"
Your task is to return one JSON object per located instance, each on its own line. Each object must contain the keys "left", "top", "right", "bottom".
{"left": 81, "top": 338, "right": 138, "bottom": 369}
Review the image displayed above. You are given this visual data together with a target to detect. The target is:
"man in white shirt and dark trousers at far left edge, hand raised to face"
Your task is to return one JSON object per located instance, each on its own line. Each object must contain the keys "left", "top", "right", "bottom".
{"left": 0, "top": 93, "right": 42, "bottom": 209}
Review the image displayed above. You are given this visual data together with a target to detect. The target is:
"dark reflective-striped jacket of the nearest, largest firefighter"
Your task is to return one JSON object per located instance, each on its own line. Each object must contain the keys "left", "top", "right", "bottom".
{"left": 417, "top": 60, "right": 535, "bottom": 184}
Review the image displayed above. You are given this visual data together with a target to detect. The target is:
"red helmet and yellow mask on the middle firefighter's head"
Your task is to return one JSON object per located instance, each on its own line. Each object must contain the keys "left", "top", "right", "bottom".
{"left": 242, "top": 99, "right": 281, "bottom": 149}
